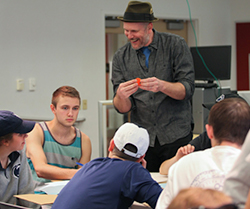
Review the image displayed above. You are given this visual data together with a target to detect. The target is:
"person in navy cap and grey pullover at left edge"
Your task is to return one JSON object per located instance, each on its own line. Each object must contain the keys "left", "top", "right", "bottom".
{"left": 0, "top": 110, "right": 35, "bottom": 207}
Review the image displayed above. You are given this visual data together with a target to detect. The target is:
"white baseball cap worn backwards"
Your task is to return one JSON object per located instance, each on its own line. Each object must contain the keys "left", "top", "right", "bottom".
{"left": 114, "top": 123, "right": 149, "bottom": 158}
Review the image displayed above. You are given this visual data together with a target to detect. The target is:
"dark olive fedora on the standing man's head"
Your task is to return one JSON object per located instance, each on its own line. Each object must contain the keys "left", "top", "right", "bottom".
{"left": 117, "top": 1, "right": 159, "bottom": 22}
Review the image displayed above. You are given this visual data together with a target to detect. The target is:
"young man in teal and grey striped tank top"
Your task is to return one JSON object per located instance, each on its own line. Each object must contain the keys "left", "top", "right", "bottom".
{"left": 26, "top": 86, "right": 91, "bottom": 190}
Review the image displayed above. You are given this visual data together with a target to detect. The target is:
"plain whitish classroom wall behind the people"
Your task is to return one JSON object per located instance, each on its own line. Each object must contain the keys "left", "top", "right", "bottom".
{"left": 0, "top": 0, "right": 250, "bottom": 158}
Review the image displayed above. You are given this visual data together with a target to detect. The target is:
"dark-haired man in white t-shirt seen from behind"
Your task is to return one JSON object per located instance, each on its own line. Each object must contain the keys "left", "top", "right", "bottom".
{"left": 156, "top": 98, "right": 250, "bottom": 209}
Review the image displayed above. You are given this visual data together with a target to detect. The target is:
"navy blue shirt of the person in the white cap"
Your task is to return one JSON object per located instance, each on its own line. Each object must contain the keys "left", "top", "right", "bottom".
{"left": 52, "top": 158, "right": 162, "bottom": 209}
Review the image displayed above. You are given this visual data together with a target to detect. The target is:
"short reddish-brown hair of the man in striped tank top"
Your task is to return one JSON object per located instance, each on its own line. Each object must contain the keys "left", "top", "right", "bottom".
{"left": 51, "top": 86, "right": 81, "bottom": 107}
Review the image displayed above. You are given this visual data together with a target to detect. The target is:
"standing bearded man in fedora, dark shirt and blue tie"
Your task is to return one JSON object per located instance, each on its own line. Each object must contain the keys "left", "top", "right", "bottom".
{"left": 112, "top": 1, "right": 194, "bottom": 172}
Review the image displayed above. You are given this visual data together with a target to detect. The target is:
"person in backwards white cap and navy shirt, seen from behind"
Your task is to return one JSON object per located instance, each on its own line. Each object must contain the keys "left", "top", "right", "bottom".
{"left": 52, "top": 123, "right": 162, "bottom": 209}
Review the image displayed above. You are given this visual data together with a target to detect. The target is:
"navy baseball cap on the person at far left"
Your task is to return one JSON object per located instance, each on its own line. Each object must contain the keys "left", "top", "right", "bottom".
{"left": 0, "top": 110, "right": 36, "bottom": 136}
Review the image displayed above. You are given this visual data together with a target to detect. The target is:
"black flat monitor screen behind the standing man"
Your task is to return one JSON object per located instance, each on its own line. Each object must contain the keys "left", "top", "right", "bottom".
{"left": 190, "top": 45, "right": 231, "bottom": 83}
